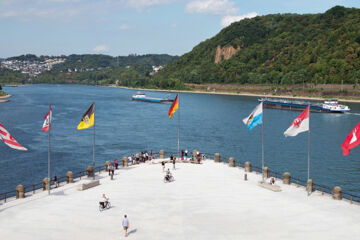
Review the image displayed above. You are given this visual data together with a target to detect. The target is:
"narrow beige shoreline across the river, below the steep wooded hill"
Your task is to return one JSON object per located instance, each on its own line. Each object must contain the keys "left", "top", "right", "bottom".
{"left": 109, "top": 85, "right": 360, "bottom": 103}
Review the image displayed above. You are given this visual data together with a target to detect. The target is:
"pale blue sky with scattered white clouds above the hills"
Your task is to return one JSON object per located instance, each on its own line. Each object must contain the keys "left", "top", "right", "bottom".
{"left": 0, "top": 0, "right": 360, "bottom": 58}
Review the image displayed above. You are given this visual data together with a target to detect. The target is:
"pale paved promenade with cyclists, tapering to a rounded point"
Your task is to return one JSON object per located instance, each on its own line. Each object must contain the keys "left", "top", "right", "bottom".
{"left": 0, "top": 161, "right": 360, "bottom": 240}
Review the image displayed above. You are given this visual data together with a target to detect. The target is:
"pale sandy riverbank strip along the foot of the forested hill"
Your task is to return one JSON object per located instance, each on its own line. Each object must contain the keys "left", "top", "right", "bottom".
{"left": 109, "top": 85, "right": 360, "bottom": 103}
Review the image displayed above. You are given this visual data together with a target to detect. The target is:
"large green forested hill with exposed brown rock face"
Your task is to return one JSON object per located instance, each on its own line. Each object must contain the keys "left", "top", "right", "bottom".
{"left": 154, "top": 6, "right": 360, "bottom": 84}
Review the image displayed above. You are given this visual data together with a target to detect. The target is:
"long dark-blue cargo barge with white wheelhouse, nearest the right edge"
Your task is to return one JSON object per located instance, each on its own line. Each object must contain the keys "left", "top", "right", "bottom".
{"left": 258, "top": 98, "right": 350, "bottom": 113}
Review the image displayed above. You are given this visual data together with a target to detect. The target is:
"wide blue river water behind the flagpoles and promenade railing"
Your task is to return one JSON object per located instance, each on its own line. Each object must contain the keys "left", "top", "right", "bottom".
{"left": 0, "top": 85, "right": 360, "bottom": 198}
